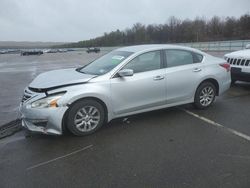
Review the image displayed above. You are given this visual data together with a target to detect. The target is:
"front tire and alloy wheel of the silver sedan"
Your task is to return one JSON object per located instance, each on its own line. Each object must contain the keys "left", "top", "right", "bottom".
{"left": 66, "top": 99, "right": 105, "bottom": 136}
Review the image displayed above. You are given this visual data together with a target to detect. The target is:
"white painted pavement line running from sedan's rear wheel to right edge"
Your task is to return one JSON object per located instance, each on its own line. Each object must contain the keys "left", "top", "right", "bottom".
{"left": 181, "top": 109, "right": 250, "bottom": 141}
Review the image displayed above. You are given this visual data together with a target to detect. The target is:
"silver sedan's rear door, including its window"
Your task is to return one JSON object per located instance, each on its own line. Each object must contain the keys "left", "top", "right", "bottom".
{"left": 164, "top": 49, "right": 203, "bottom": 104}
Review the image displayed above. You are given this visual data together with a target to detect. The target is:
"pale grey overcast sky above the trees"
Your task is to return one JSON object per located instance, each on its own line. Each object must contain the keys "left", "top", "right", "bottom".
{"left": 0, "top": 0, "right": 250, "bottom": 42}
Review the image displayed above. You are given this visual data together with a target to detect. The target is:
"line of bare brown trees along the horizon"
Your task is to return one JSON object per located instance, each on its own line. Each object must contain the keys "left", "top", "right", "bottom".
{"left": 60, "top": 13, "right": 250, "bottom": 48}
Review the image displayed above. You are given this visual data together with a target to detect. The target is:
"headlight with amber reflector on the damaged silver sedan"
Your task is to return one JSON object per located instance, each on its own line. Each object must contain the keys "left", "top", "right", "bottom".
{"left": 31, "top": 93, "right": 63, "bottom": 108}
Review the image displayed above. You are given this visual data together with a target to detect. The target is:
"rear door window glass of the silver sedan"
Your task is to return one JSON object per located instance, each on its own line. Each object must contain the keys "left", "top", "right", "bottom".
{"left": 165, "top": 50, "right": 194, "bottom": 67}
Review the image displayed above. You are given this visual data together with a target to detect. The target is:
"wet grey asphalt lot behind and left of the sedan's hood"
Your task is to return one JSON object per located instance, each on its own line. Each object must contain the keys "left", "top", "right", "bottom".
{"left": 0, "top": 51, "right": 107, "bottom": 127}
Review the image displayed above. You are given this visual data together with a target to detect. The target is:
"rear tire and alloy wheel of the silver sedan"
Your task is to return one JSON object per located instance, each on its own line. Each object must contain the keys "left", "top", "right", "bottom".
{"left": 194, "top": 82, "right": 216, "bottom": 109}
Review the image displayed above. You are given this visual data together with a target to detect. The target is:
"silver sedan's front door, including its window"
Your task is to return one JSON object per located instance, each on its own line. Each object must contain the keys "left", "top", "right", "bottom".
{"left": 110, "top": 51, "right": 166, "bottom": 115}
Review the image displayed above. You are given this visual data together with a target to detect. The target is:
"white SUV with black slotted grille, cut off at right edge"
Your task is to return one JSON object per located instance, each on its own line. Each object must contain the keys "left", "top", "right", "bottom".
{"left": 224, "top": 49, "right": 250, "bottom": 83}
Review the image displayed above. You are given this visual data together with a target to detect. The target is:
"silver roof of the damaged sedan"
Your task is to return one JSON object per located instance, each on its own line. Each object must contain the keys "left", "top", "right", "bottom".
{"left": 116, "top": 44, "right": 203, "bottom": 54}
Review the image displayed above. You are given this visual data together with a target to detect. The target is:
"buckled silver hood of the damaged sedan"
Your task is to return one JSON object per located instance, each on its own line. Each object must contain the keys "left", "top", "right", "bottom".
{"left": 29, "top": 68, "right": 96, "bottom": 91}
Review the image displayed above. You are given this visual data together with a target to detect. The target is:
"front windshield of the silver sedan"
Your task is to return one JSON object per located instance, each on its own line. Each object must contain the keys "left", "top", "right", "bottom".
{"left": 78, "top": 51, "right": 132, "bottom": 75}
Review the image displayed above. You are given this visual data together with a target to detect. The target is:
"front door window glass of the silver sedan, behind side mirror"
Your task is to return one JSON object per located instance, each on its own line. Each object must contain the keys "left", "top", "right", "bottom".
{"left": 123, "top": 51, "right": 161, "bottom": 73}
